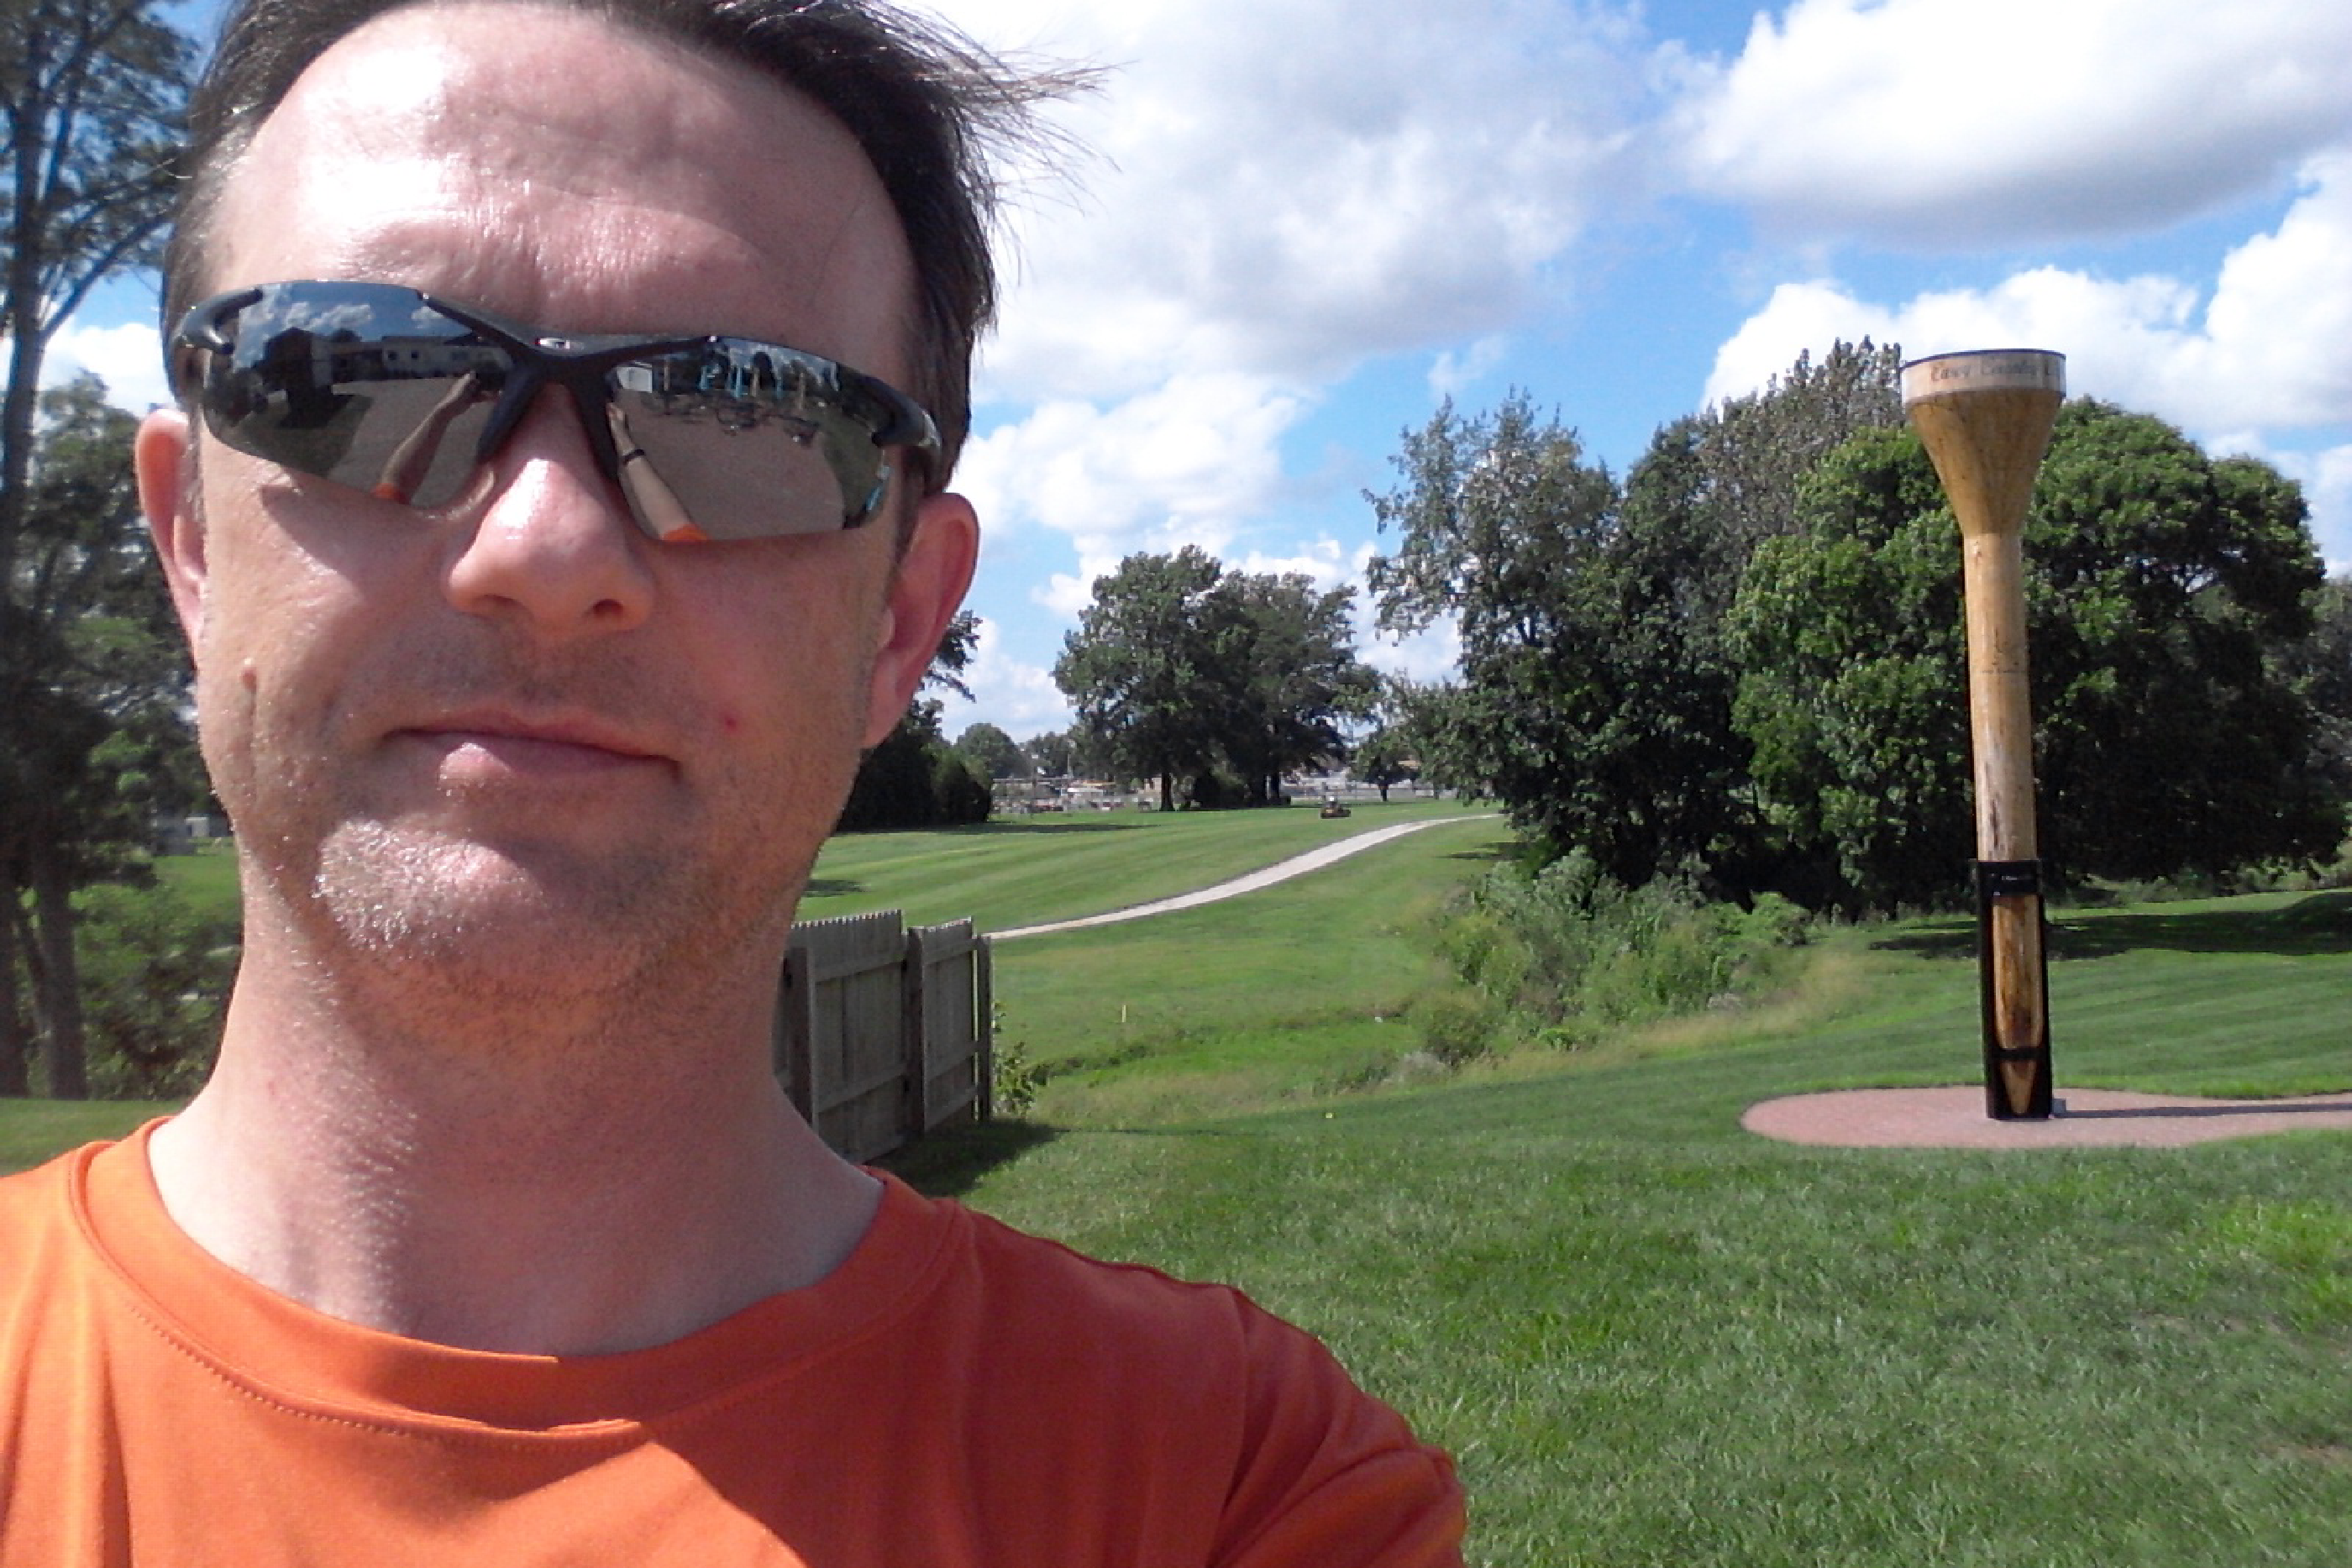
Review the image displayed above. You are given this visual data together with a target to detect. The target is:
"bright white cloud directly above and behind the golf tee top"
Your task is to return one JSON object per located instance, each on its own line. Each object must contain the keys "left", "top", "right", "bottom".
{"left": 1705, "top": 153, "right": 2352, "bottom": 430}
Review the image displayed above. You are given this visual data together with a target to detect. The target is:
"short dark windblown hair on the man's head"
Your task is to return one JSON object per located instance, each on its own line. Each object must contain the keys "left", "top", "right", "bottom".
{"left": 162, "top": 0, "right": 1087, "bottom": 489}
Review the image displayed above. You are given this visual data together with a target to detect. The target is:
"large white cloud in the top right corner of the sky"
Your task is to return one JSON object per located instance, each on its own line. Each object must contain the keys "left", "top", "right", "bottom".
{"left": 1679, "top": 0, "right": 2352, "bottom": 249}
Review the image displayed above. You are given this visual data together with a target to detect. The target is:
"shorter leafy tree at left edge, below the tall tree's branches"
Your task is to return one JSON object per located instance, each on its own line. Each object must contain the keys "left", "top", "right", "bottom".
{"left": 0, "top": 376, "right": 202, "bottom": 1098}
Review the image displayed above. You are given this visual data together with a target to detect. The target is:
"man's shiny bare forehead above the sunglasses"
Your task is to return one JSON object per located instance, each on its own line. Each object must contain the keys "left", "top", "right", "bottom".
{"left": 217, "top": 0, "right": 912, "bottom": 357}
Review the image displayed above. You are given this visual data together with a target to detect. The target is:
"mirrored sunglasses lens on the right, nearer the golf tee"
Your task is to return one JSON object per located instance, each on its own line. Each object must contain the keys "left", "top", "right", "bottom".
{"left": 606, "top": 338, "right": 882, "bottom": 538}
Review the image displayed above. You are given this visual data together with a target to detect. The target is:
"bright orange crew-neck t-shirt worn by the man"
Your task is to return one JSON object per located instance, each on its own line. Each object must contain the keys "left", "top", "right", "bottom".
{"left": 0, "top": 1129, "right": 1461, "bottom": 1568}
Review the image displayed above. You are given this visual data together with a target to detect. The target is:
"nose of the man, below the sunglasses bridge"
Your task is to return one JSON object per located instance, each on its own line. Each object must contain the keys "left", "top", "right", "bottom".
{"left": 444, "top": 385, "right": 654, "bottom": 637}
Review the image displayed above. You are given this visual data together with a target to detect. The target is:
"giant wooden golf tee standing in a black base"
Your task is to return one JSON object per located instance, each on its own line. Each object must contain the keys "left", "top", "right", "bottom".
{"left": 1903, "top": 348, "right": 2065, "bottom": 1121}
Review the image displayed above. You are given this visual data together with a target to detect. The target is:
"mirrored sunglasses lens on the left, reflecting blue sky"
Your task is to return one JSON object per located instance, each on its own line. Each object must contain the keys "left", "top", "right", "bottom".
{"left": 205, "top": 285, "right": 512, "bottom": 506}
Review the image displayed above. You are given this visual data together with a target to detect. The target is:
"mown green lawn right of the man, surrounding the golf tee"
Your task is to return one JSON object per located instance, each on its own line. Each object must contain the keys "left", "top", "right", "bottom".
{"left": 18, "top": 811, "right": 2352, "bottom": 1568}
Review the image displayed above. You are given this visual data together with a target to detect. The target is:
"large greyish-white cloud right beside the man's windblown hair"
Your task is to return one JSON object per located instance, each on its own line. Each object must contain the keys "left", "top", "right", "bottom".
{"left": 950, "top": 0, "right": 1646, "bottom": 400}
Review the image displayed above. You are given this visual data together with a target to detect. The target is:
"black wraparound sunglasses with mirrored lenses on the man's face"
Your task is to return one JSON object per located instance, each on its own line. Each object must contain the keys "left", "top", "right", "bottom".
{"left": 174, "top": 282, "right": 938, "bottom": 541}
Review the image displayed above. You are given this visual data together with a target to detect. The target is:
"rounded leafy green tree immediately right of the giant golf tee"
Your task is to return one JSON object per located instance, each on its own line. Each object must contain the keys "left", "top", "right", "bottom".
{"left": 2028, "top": 416, "right": 2343, "bottom": 879}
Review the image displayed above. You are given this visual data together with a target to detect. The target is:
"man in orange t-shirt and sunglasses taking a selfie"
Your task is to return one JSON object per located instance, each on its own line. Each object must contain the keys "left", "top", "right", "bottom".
{"left": 0, "top": 0, "right": 1461, "bottom": 1568}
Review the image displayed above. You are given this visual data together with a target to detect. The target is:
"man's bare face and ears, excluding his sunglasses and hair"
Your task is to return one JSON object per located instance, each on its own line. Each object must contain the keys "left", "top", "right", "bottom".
{"left": 141, "top": 5, "right": 971, "bottom": 997}
